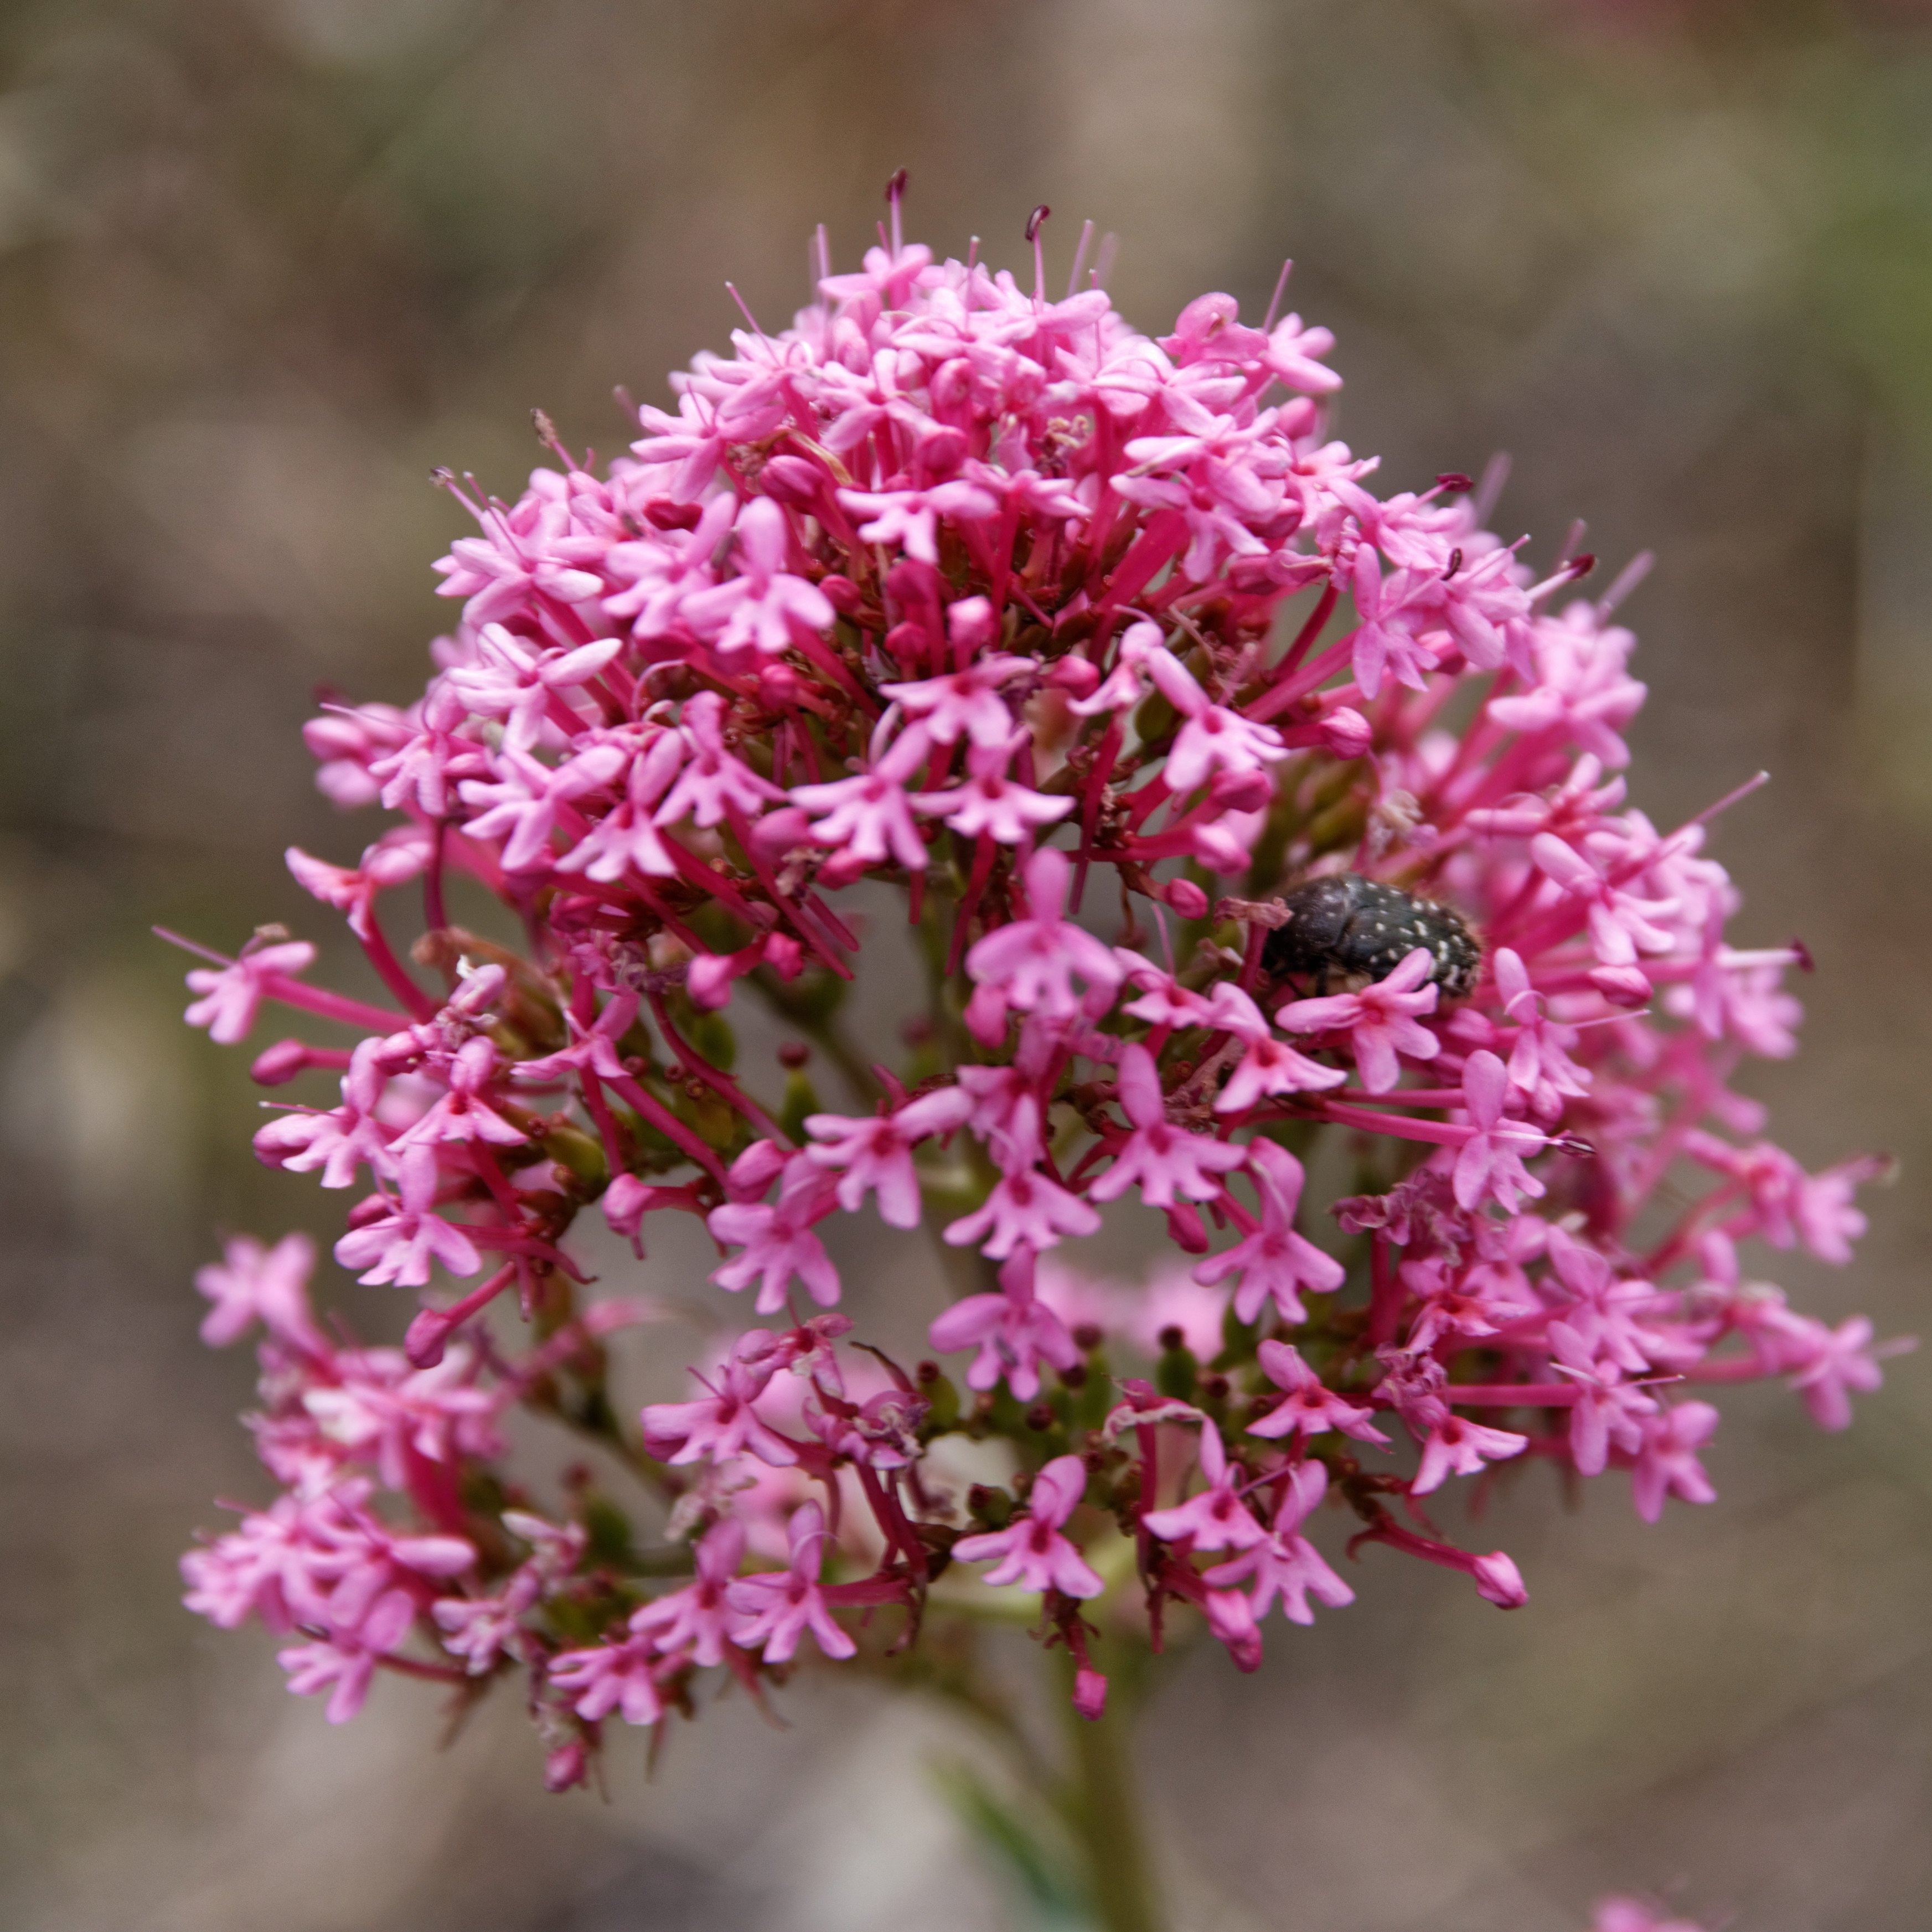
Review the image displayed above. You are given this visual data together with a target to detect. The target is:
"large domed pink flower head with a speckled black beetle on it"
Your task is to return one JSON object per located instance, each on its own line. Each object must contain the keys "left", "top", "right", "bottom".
{"left": 184, "top": 184, "right": 1884, "bottom": 1808}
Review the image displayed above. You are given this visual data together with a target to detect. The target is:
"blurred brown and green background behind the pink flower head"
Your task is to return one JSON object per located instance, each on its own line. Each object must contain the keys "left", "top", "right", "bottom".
{"left": 0, "top": 0, "right": 1932, "bottom": 1932}
